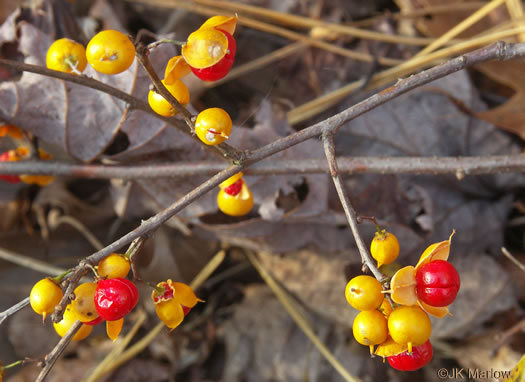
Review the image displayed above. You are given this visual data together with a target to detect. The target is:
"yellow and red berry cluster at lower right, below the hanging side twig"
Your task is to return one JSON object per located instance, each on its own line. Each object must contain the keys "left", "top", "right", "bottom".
{"left": 345, "top": 229, "right": 460, "bottom": 371}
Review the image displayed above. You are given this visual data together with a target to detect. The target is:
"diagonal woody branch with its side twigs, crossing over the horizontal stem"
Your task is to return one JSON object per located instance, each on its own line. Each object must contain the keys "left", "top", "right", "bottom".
{"left": 7, "top": 42, "right": 525, "bottom": 381}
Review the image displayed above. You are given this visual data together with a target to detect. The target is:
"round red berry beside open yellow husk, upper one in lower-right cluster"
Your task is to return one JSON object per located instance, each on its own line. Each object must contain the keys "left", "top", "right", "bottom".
{"left": 416, "top": 260, "right": 460, "bottom": 307}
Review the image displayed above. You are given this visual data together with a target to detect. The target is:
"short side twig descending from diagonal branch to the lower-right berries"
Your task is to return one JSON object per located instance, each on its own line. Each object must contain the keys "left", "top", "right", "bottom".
{"left": 323, "top": 133, "right": 385, "bottom": 282}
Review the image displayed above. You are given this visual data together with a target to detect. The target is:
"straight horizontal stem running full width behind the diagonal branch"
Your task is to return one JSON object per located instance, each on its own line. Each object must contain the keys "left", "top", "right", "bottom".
{"left": 0, "top": 154, "right": 525, "bottom": 180}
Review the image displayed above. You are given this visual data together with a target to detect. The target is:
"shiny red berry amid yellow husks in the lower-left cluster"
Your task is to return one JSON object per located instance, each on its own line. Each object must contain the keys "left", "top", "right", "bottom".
{"left": 95, "top": 278, "right": 139, "bottom": 321}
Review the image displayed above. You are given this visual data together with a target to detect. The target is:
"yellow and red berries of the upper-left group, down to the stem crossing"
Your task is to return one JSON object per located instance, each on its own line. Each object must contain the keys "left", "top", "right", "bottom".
{"left": 43, "top": 16, "right": 253, "bottom": 216}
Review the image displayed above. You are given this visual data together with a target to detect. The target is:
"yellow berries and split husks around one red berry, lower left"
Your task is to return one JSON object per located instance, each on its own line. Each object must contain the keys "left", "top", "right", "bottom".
{"left": 29, "top": 253, "right": 202, "bottom": 341}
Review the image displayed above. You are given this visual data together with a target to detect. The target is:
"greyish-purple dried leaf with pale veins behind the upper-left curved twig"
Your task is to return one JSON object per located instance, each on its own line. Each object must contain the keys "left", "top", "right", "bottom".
{"left": 0, "top": 20, "right": 183, "bottom": 161}
